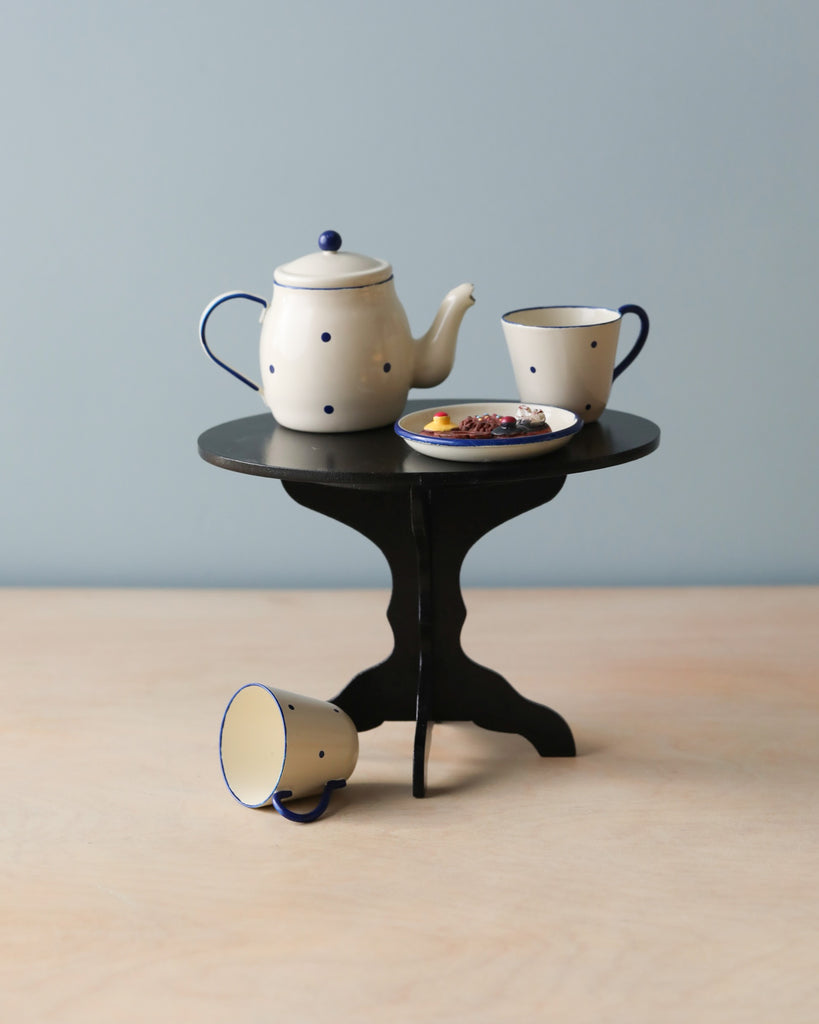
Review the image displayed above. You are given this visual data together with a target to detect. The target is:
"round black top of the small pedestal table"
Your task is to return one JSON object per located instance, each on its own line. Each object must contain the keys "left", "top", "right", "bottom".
{"left": 199, "top": 398, "right": 659, "bottom": 487}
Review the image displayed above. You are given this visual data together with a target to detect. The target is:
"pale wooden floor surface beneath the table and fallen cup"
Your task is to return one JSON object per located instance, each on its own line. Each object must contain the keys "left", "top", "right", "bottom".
{"left": 0, "top": 588, "right": 819, "bottom": 1024}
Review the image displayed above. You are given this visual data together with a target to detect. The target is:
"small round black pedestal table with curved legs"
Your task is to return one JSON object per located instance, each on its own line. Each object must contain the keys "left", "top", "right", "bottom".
{"left": 199, "top": 398, "right": 659, "bottom": 797}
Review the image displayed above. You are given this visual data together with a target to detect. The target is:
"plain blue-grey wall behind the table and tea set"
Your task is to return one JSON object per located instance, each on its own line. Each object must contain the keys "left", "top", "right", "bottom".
{"left": 0, "top": 0, "right": 819, "bottom": 587}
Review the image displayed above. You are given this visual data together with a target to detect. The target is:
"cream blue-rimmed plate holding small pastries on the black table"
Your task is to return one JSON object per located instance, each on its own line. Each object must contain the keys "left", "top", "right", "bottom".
{"left": 395, "top": 401, "right": 583, "bottom": 462}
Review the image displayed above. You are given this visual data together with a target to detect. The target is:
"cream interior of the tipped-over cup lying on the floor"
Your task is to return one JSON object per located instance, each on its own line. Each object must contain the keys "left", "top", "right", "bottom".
{"left": 219, "top": 683, "right": 286, "bottom": 807}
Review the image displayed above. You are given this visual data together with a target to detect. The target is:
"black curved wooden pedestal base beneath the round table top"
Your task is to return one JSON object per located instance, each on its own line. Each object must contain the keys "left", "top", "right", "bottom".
{"left": 284, "top": 477, "right": 575, "bottom": 797}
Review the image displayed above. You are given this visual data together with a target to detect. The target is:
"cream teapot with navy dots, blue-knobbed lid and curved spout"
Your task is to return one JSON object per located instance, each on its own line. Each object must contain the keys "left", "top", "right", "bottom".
{"left": 199, "top": 231, "right": 475, "bottom": 433}
